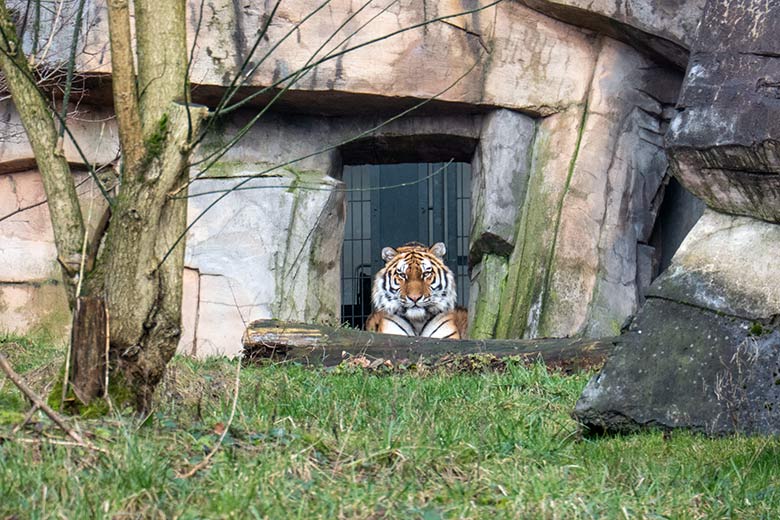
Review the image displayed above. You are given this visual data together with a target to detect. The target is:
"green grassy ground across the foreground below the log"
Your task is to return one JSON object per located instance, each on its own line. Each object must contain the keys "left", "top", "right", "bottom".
{"left": 0, "top": 337, "right": 780, "bottom": 519}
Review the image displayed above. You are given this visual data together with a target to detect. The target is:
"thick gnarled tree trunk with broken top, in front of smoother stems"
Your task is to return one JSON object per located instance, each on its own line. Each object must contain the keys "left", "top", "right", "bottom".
{"left": 84, "top": 104, "right": 207, "bottom": 412}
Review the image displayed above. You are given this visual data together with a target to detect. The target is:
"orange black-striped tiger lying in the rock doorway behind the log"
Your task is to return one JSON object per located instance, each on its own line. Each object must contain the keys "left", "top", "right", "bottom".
{"left": 366, "top": 242, "right": 468, "bottom": 339}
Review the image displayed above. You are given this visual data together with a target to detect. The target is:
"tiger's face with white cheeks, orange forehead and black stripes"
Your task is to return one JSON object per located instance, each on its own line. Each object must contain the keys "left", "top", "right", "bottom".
{"left": 371, "top": 242, "right": 457, "bottom": 324}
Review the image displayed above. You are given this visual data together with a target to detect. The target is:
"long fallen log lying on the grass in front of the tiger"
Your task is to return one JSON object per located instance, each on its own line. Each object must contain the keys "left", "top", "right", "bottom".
{"left": 242, "top": 320, "right": 623, "bottom": 371}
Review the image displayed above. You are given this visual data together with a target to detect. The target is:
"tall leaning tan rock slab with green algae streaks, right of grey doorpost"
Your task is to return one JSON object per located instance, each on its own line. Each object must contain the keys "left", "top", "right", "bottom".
{"left": 488, "top": 39, "right": 678, "bottom": 337}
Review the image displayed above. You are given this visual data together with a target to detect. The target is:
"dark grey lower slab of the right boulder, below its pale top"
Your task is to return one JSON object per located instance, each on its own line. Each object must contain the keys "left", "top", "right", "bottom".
{"left": 573, "top": 298, "right": 780, "bottom": 435}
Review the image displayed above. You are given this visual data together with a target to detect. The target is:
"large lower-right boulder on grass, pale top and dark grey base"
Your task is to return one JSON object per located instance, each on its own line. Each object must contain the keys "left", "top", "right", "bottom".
{"left": 574, "top": 210, "right": 780, "bottom": 434}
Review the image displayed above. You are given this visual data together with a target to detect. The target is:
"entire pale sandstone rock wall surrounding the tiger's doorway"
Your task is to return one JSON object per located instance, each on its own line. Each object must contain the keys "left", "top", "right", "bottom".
{"left": 0, "top": 0, "right": 700, "bottom": 355}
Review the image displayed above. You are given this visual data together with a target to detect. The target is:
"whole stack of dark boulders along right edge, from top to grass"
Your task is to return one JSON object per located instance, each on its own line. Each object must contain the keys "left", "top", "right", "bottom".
{"left": 574, "top": 0, "right": 780, "bottom": 435}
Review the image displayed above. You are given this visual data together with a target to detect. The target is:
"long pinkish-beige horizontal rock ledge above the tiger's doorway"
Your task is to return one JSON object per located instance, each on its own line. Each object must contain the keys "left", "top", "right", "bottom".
{"left": 61, "top": 0, "right": 594, "bottom": 115}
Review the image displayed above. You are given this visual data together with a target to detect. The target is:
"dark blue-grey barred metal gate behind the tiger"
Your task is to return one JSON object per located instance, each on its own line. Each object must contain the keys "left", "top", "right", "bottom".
{"left": 341, "top": 163, "right": 471, "bottom": 328}
